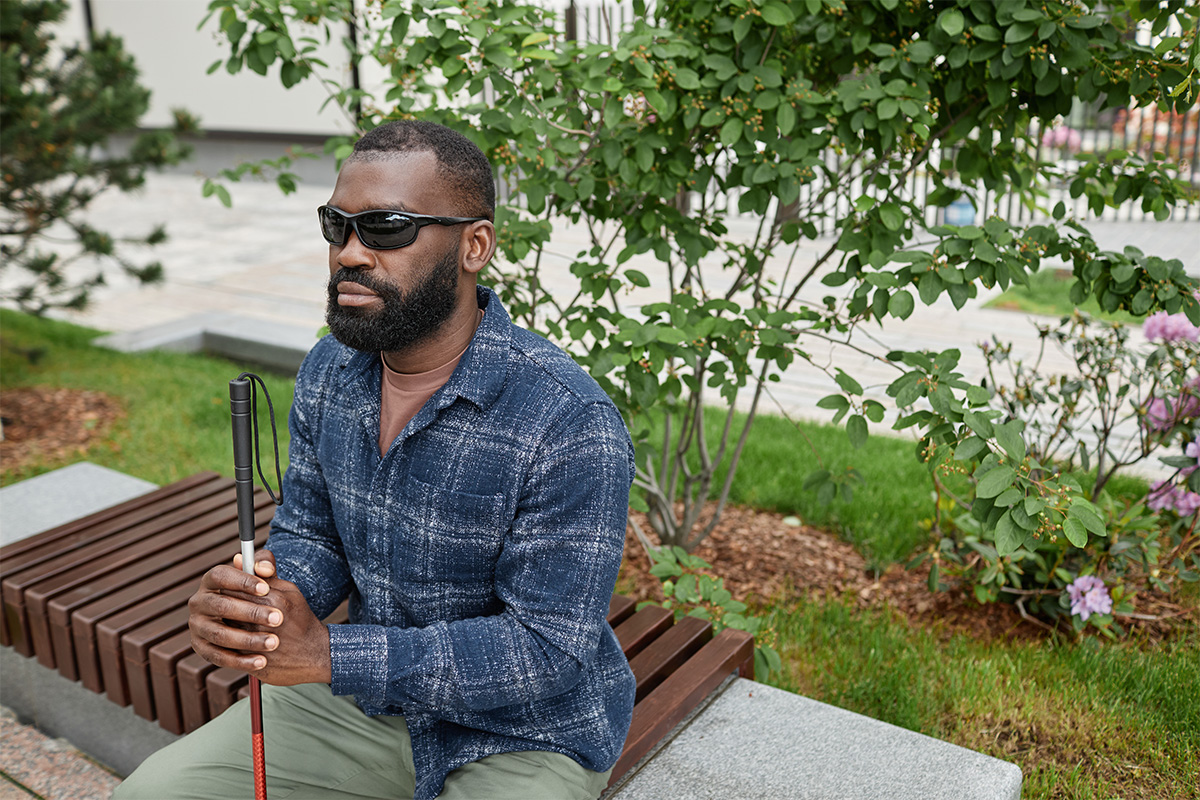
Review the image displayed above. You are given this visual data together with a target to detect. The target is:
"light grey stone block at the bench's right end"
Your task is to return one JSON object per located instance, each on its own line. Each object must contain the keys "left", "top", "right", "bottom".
{"left": 613, "top": 678, "right": 1021, "bottom": 800}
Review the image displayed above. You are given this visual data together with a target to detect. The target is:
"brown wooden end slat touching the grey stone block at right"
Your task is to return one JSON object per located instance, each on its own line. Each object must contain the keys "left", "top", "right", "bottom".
{"left": 610, "top": 627, "right": 754, "bottom": 786}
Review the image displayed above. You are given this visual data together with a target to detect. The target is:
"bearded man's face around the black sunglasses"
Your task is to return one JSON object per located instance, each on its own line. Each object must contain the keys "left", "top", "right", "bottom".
{"left": 325, "top": 152, "right": 460, "bottom": 353}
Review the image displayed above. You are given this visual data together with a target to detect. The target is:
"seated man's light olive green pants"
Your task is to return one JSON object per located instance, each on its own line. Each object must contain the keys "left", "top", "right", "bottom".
{"left": 113, "top": 684, "right": 608, "bottom": 800}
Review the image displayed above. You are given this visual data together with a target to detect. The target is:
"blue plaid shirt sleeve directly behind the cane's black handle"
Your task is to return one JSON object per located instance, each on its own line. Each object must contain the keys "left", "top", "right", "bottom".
{"left": 266, "top": 345, "right": 352, "bottom": 619}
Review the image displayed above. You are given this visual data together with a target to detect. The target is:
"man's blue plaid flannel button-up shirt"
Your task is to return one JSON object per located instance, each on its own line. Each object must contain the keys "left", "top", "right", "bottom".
{"left": 268, "top": 288, "right": 634, "bottom": 799}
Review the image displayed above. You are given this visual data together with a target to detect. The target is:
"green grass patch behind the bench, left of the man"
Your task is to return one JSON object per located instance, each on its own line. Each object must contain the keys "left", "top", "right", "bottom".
{"left": 0, "top": 311, "right": 294, "bottom": 485}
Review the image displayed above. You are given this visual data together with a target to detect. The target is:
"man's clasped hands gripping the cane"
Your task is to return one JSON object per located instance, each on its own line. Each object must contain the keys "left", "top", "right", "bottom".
{"left": 187, "top": 551, "right": 332, "bottom": 686}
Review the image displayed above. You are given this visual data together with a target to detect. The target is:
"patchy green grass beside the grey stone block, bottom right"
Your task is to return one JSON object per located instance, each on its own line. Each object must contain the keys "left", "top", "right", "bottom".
{"left": 769, "top": 600, "right": 1200, "bottom": 800}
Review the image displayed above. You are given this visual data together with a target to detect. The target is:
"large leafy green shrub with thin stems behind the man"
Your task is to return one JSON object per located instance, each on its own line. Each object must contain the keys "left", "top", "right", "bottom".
{"left": 201, "top": 0, "right": 1200, "bottom": 549}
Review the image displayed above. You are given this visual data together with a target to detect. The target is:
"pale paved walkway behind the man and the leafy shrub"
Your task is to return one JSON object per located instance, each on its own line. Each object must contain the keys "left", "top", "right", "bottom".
{"left": 28, "top": 174, "right": 1200, "bottom": 474}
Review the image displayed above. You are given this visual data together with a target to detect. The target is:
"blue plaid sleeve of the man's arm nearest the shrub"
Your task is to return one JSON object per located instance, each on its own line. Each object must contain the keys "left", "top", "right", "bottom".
{"left": 330, "top": 403, "right": 632, "bottom": 718}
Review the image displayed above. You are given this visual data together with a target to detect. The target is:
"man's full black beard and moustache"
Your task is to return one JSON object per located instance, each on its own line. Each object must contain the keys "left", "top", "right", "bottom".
{"left": 325, "top": 247, "right": 458, "bottom": 353}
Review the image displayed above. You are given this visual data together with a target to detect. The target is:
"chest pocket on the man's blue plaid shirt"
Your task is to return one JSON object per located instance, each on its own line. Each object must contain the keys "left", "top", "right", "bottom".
{"left": 392, "top": 477, "right": 508, "bottom": 587}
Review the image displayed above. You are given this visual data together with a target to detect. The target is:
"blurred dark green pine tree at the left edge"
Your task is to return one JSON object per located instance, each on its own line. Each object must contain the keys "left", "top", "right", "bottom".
{"left": 0, "top": 0, "right": 194, "bottom": 314}
